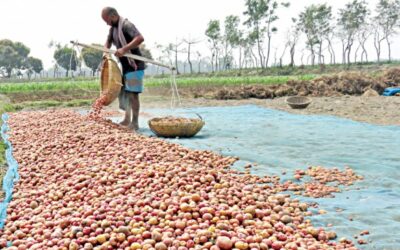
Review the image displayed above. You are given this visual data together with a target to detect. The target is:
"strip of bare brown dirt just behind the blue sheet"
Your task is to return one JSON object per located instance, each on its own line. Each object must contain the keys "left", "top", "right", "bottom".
{"left": 135, "top": 95, "right": 400, "bottom": 126}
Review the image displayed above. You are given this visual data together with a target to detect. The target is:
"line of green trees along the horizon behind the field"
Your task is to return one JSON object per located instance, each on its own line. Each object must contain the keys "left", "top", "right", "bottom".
{"left": 0, "top": 0, "right": 400, "bottom": 77}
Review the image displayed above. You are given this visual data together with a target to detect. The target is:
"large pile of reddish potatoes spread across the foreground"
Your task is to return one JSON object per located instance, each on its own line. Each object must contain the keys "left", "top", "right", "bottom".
{"left": 0, "top": 110, "right": 355, "bottom": 250}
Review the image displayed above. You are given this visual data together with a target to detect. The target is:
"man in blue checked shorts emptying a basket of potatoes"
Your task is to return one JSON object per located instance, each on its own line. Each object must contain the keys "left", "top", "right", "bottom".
{"left": 101, "top": 7, "right": 145, "bottom": 131}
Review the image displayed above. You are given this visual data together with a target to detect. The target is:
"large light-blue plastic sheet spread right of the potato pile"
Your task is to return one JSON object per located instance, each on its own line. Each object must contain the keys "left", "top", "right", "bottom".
{"left": 130, "top": 105, "right": 400, "bottom": 249}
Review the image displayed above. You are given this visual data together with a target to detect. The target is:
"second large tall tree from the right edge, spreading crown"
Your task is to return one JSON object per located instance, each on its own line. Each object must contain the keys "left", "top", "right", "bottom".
{"left": 338, "top": 0, "right": 369, "bottom": 66}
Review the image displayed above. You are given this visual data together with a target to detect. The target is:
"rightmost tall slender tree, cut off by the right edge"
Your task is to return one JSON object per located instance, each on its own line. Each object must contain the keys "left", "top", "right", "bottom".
{"left": 373, "top": 0, "right": 400, "bottom": 61}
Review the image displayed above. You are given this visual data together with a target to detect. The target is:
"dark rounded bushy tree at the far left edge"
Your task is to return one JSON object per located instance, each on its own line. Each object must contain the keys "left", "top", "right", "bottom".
{"left": 0, "top": 39, "right": 30, "bottom": 78}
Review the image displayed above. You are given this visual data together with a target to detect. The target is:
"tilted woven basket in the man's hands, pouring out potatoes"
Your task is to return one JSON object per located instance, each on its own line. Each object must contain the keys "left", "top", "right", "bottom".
{"left": 100, "top": 54, "right": 122, "bottom": 106}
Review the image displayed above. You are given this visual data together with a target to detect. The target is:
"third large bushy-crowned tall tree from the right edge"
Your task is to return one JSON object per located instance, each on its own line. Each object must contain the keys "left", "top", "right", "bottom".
{"left": 299, "top": 4, "right": 332, "bottom": 65}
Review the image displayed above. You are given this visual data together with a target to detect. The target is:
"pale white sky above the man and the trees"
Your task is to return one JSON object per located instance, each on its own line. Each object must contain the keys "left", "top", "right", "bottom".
{"left": 0, "top": 0, "right": 399, "bottom": 69}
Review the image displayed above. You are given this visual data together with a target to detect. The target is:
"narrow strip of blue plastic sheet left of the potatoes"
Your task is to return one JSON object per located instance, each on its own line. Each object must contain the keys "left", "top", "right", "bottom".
{"left": 0, "top": 114, "right": 19, "bottom": 228}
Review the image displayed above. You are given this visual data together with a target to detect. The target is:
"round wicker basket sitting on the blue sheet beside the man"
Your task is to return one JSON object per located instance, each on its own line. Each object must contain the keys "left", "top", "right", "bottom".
{"left": 148, "top": 116, "right": 205, "bottom": 138}
